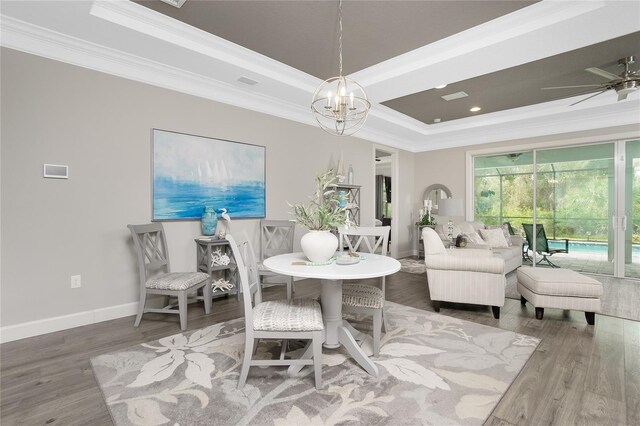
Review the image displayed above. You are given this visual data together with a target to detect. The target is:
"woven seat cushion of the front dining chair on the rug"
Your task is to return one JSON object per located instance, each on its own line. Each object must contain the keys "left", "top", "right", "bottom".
{"left": 253, "top": 299, "right": 324, "bottom": 331}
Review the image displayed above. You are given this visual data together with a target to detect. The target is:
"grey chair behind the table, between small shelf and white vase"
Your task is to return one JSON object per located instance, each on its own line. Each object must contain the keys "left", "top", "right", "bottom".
{"left": 258, "top": 219, "right": 296, "bottom": 300}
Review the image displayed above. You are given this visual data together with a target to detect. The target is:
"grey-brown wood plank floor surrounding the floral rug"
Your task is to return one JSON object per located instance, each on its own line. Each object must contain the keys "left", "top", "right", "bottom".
{"left": 0, "top": 272, "right": 640, "bottom": 426}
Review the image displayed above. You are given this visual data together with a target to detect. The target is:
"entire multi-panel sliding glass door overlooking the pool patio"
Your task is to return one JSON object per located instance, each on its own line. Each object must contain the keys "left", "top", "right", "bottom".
{"left": 473, "top": 140, "right": 640, "bottom": 278}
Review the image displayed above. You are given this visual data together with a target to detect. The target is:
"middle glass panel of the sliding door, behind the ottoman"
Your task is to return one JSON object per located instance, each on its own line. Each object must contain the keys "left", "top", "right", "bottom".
{"left": 536, "top": 143, "right": 616, "bottom": 275}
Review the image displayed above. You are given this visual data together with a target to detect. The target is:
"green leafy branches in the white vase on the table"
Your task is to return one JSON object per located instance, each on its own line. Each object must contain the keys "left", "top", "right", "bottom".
{"left": 289, "top": 170, "right": 350, "bottom": 231}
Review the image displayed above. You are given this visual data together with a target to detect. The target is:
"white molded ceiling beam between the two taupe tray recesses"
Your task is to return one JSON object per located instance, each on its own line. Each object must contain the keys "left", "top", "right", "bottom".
{"left": 352, "top": 1, "right": 640, "bottom": 102}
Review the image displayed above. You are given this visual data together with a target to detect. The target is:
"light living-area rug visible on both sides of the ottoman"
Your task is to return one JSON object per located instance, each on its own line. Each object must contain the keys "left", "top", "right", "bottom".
{"left": 505, "top": 271, "right": 640, "bottom": 321}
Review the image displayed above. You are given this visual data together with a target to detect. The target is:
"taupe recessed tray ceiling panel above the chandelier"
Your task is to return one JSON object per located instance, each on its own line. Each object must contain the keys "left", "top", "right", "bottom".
{"left": 135, "top": 0, "right": 537, "bottom": 80}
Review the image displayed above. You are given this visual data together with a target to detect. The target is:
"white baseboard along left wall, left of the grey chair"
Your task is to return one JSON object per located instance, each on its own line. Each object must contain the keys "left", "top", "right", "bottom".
{"left": 0, "top": 302, "right": 138, "bottom": 343}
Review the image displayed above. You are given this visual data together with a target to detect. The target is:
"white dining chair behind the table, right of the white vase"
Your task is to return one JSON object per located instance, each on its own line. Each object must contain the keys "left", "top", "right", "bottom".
{"left": 338, "top": 226, "right": 391, "bottom": 357}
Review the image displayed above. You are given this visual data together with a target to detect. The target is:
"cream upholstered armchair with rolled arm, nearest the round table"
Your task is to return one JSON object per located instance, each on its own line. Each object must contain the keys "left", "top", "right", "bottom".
{"left": 422, "top": 228, "right": 506, "bottom": 319}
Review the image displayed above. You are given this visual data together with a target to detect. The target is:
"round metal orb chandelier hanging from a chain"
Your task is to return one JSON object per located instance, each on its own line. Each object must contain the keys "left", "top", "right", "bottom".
{"left": 311, "top": 0, "right": 371, "bottom": 136}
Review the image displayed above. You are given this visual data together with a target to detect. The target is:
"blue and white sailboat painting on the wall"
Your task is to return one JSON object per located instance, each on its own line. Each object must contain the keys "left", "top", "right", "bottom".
{"left": 152, "top": 129, "right": 265, "bottom": 221}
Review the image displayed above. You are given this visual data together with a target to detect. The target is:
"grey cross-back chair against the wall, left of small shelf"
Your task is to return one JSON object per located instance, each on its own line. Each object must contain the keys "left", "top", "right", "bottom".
{"left": 127, "top": 222, "right": 212, "bottom": 331}
